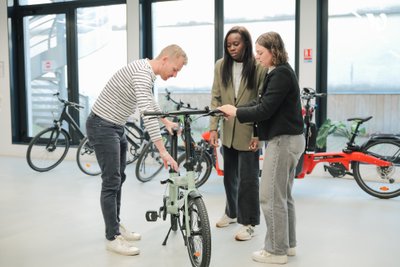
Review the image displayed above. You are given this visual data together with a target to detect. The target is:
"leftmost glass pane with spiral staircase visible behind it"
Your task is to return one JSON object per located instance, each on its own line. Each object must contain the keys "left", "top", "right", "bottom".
{"left": 24, "top": 14, "right": 67, "bottom": 136}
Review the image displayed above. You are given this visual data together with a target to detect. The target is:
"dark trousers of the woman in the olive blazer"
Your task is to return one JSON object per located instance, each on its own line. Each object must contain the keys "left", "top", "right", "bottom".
{"left": 223, "top": 146, "right": 260, "bottom": 225}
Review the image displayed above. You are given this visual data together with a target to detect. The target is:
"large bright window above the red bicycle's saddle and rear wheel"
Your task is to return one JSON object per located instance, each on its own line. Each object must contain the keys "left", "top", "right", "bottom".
{"left": 327, "top": 0, "right": 400, "bottom": 140}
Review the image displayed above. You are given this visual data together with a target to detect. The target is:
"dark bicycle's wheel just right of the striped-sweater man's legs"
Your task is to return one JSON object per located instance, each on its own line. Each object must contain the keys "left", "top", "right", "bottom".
{"left": 135, "top": 141, "right": 164, "bottom": 183}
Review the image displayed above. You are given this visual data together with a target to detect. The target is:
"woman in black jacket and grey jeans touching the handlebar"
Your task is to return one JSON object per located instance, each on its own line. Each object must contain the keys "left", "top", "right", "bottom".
{"left": 219, "top": 32, "right": 305, "bottom": 264}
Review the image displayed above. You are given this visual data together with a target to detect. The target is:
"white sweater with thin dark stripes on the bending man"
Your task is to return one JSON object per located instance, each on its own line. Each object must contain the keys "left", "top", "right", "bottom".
{"left": 92, "top": 59, "right": 161, "bottom": 142}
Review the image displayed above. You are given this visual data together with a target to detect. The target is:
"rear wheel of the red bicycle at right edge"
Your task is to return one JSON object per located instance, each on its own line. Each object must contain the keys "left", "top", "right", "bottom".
{"left": 353, "top": 140, "right": 400, "bottom": 199}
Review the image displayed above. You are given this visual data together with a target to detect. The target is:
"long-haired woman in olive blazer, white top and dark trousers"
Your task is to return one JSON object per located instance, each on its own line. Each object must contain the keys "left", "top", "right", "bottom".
{"left": 210, "top": 26, "right": 266, "bottom": 241}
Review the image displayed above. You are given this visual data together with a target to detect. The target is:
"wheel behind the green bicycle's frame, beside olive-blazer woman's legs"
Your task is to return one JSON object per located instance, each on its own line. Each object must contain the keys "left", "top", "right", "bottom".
{"left": 178, "top": 149, "right": 212, "bottom": 188}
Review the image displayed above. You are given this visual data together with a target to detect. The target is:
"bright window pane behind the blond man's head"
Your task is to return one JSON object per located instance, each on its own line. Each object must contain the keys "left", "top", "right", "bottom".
{"left": 152, "top": 0, "right": 214, "bottom": 95}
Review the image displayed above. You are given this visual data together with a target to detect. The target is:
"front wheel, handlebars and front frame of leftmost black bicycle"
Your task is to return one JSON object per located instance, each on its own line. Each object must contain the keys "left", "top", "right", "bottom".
{"left": 26, "top": 92, "right": 85, "bottom": 172}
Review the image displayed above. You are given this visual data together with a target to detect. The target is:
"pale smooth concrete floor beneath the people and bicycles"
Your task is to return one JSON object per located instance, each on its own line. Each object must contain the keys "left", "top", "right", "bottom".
{"left": 0, "top": 157, "right": 400, "bottom": 267}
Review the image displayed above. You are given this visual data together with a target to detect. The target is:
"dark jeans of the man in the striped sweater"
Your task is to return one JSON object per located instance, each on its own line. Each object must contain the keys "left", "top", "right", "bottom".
{"left": 86, "top": 113, "right": 128, "bottom": 240}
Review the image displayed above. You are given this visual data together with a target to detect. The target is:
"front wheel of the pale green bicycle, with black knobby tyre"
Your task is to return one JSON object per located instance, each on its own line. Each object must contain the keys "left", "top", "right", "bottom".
{"left": 182, "top": 196, "right": 211, "bottom": 267}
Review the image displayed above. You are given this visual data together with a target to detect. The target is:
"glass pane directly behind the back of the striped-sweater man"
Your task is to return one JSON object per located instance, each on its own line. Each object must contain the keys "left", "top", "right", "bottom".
{"left": 77, "top": 5, "right": 127, "bottom": 130}
